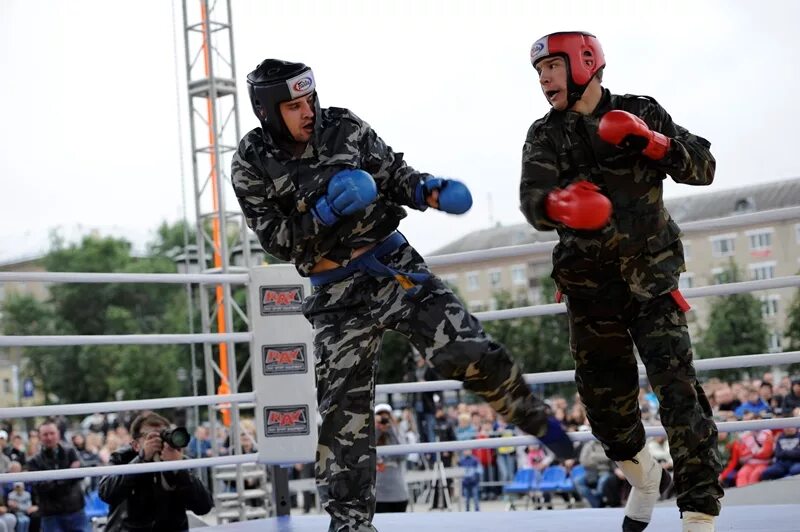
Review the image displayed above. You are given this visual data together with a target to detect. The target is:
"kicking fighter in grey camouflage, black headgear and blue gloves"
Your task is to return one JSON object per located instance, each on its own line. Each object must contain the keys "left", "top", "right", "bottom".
{"left": 232, "top": 59, "right": 574, "bottom": 531}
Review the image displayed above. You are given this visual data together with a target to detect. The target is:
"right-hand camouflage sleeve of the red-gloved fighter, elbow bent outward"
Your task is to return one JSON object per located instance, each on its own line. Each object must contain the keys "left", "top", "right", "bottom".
{"left": 642, "top": 100, "right": 717, "bottom": 185}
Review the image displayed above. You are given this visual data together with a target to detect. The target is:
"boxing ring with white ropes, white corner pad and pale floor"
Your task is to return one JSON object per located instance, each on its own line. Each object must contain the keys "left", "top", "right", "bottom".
{"left": 0, "top": 208, "right": 800, "bottom": 532}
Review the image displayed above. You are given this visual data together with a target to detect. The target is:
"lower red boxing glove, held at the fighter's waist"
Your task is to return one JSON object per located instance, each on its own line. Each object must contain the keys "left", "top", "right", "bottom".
{"left": 544, "top": 181, "right": 611, "bottom": 230}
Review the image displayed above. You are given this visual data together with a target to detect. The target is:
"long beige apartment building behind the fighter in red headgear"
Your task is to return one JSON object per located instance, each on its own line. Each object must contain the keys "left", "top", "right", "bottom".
{"left": 429, "top": 178, "right": 800, "bottom": 351}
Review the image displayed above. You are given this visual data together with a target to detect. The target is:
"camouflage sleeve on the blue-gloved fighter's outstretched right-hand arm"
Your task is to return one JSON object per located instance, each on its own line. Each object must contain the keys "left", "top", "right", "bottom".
{"left": 360, "top": 121, "right": 431, "bottom": 211}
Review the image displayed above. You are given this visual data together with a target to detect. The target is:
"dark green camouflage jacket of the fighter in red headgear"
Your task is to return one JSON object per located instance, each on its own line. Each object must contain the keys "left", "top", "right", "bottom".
{"left": 520, "top": 89, "right": 716, "bottom": 300}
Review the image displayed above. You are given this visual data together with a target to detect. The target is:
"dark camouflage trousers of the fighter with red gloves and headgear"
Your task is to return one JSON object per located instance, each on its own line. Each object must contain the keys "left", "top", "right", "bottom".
{"left": 567, "top": 286, "right": 723, "bottom": 515}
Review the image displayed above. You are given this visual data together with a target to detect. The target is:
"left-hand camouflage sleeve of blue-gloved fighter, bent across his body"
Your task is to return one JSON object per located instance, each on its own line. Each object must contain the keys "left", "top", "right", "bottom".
{"left": 231, "top": 141, "right": 330, "bottom": 261}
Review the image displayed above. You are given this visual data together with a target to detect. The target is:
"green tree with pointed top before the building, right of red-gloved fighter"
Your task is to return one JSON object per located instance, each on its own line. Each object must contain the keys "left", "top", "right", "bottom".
{"left": 695, "top": 264, "right": 768, "bottom": 379}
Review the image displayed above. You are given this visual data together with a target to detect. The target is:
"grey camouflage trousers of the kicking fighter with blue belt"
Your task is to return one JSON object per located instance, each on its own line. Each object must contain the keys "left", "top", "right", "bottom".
{"left": 303, "top": 244, "right": 546, "bottom": 532}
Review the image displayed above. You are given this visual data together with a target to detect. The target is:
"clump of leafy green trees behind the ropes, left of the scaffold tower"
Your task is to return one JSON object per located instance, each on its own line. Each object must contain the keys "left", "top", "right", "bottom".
{"left": 6, "top": 225, "right": 188, "bottom": 403}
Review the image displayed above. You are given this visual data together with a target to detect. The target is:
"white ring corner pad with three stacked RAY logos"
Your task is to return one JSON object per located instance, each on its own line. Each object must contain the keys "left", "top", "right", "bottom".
{"left": 249, "top": 264, "right": 317, "bottom": 464}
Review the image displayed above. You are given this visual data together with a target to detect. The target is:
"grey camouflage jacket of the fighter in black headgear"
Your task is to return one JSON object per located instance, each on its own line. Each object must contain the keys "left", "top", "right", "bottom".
{"left": 231, "top": 107, "right": 430, "bottom": 276}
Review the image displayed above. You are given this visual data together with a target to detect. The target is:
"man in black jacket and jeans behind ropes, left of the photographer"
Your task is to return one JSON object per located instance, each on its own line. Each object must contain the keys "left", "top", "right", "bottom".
{"left": 28, "top": 421, "right": 89, "bottom": 532}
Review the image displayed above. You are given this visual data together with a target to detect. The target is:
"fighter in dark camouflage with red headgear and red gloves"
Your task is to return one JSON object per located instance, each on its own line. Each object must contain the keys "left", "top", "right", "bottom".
{"left": 520, "top": 32, "right": 723, "bottom": 531}
